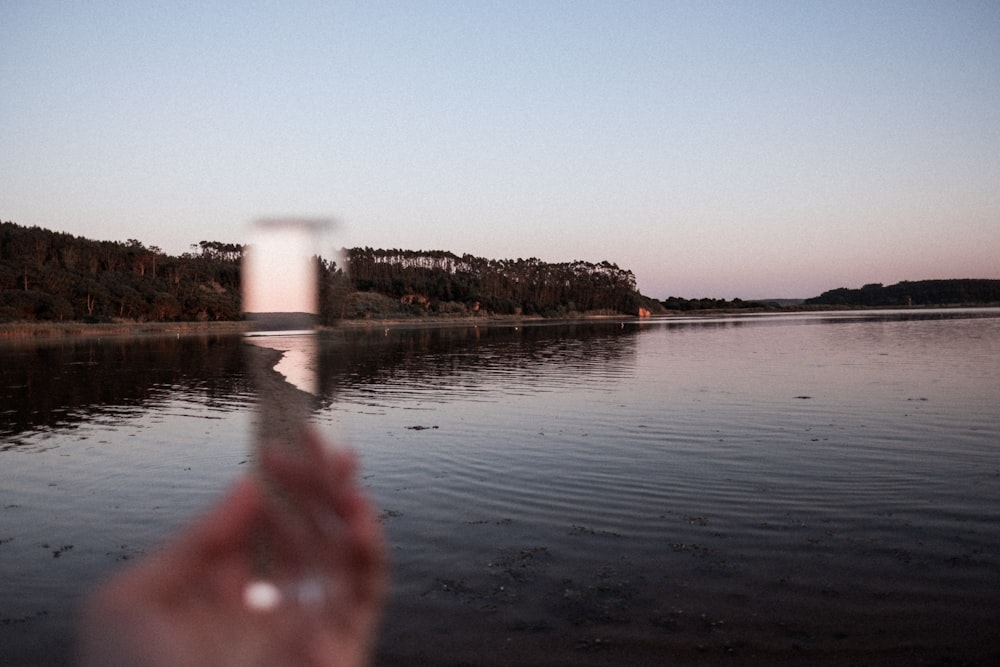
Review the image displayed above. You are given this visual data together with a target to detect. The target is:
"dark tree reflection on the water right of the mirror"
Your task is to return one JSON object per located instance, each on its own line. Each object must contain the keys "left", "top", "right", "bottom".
{"left": 321, "top": 322, "right": 639, "bottom": 398}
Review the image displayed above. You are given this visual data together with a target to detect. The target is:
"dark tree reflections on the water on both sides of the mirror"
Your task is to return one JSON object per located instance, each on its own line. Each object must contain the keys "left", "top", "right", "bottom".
{"left": 0, "top": 323, "right": 639, "bottom": 448}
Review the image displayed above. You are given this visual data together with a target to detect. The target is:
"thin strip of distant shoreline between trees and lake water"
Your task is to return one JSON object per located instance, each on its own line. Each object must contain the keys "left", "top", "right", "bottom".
{"left": 0, "top": 303, "right": 1000, "bottom": 342}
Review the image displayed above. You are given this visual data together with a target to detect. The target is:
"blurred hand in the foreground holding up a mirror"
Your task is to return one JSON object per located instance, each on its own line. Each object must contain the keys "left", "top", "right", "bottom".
{"left": 80, "top": 433, "right": 386, "bottom": 667}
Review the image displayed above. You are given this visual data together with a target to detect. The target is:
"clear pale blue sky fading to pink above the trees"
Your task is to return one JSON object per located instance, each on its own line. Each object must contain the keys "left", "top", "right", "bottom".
{"left": 0, "top": 0, "right": 1000, "bottom": 299}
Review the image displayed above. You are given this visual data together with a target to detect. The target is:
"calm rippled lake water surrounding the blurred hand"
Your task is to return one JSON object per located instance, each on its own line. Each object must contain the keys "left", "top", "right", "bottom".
{"left": 0, "top": 309, "right": 1000, "bottom": 665}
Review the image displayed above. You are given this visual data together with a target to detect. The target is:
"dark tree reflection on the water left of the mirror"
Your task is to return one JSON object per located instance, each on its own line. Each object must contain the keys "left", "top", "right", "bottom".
{"left": 0, "top": 336, "right": 248, "bottom": 447}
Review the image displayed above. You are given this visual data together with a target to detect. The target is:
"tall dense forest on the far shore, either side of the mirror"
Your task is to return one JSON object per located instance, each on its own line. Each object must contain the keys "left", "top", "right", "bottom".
{"left": 0, "top": 222, "right": 662, "bottom": 323}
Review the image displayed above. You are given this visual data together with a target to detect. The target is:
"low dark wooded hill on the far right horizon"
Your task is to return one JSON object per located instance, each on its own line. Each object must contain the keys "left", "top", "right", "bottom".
{"left": 805, "top": 279, "right": 1000, "bottom": 307}
